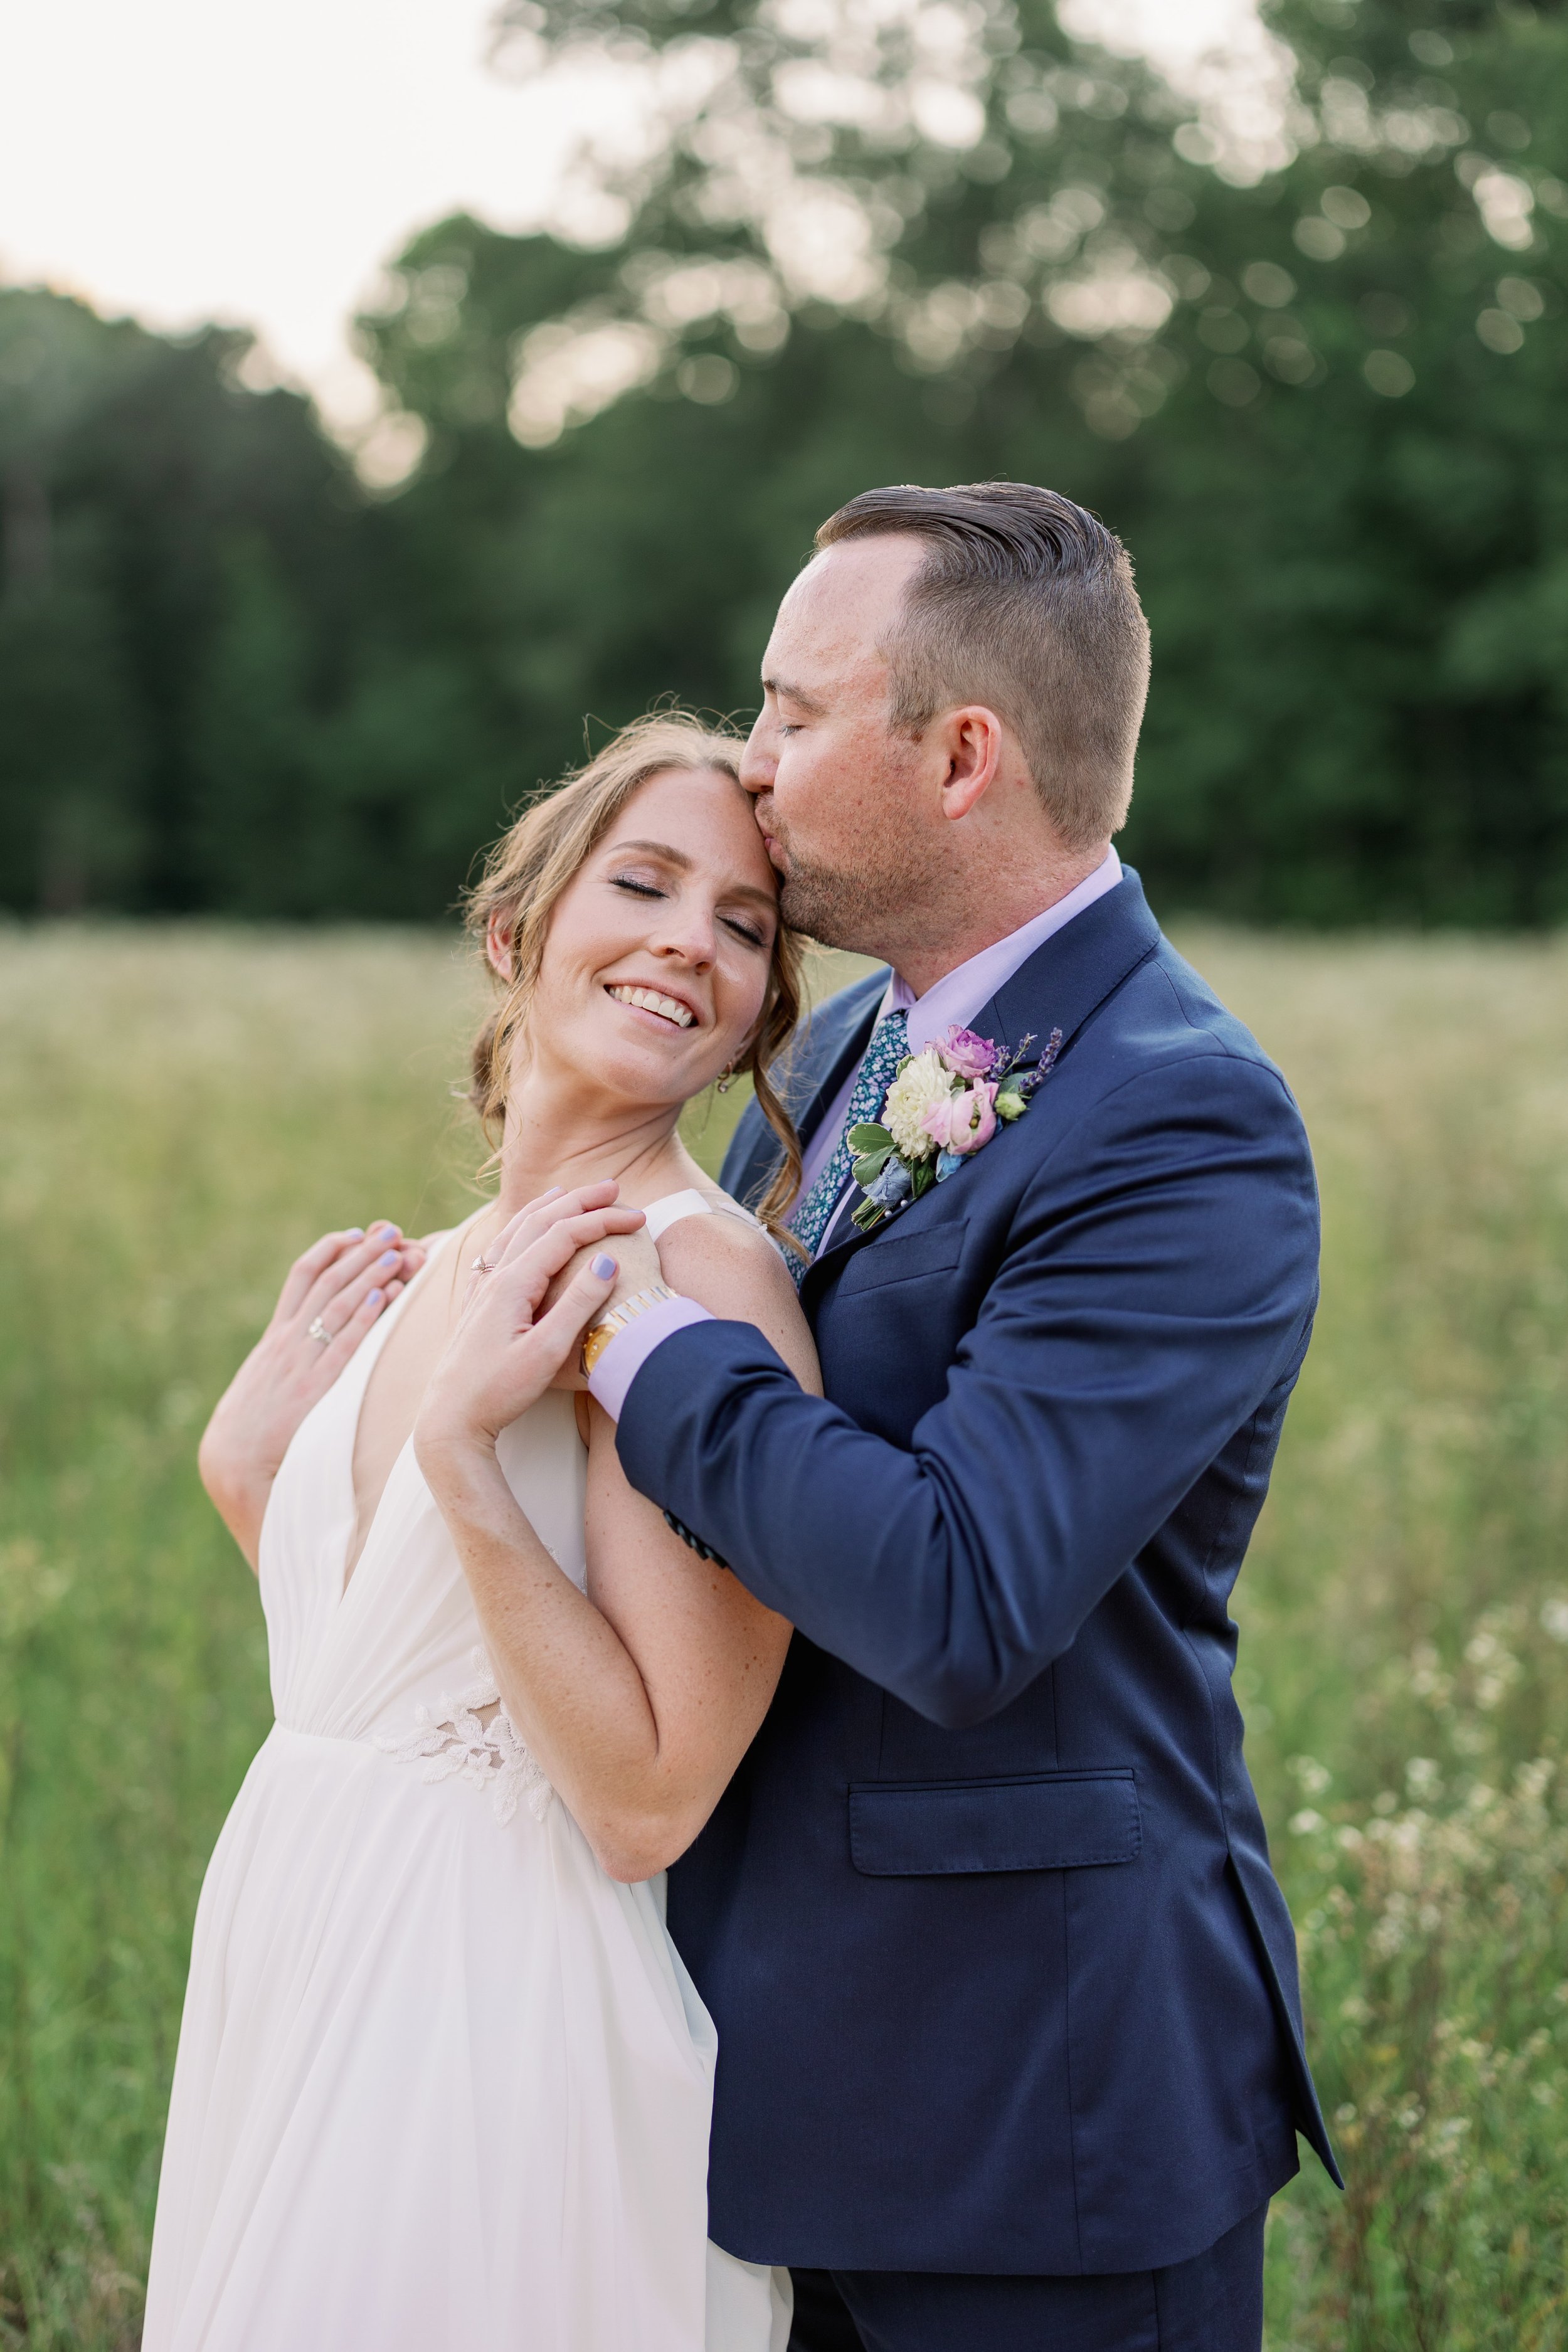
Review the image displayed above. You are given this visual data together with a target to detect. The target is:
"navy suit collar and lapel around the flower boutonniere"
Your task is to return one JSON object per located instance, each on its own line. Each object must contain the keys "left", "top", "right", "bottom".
{"left": 802, "top": 866, "right": 1159, "bottom": 1313}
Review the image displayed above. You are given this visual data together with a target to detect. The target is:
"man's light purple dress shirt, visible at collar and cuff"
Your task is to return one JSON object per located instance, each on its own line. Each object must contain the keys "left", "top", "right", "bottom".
{"left": 588, "top": 849, "right": 1121, "bottom": 1421}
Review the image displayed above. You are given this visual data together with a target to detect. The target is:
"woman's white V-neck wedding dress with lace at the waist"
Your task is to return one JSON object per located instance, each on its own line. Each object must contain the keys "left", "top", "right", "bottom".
{"left": 144, "top": 1192, "right": 790, "bottom": 2352}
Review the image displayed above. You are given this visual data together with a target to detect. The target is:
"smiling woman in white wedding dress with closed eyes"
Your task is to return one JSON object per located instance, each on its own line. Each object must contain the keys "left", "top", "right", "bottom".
{"left": 144, "top": 718, "right": 818, "bottom": 2352}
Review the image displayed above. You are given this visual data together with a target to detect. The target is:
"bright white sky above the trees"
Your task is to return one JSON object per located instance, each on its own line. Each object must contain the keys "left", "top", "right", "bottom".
{"left": 0, "top": 0, "right": 1258, "bottom": 423}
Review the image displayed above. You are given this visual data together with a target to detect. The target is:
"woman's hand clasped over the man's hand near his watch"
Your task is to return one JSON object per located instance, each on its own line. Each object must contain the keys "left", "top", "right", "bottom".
{"left": 414, "top": 1183, "right": 644, "bottom": 1480}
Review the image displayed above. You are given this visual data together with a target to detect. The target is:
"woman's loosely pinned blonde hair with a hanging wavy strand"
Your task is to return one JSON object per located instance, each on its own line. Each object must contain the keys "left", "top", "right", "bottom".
{"left": 465, "top": 711, "right": 802, "bottom": 1247}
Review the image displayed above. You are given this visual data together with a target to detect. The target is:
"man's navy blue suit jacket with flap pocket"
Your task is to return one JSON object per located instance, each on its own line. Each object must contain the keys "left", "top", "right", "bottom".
{"left": 618, "top": 872, "right": 1338, "bottom": 2272}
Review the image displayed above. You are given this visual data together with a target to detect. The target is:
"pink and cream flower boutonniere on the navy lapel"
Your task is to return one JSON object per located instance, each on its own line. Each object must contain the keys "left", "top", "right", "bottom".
{"left": 849, "top": 1028, "right": 1062, "bottom": 1232}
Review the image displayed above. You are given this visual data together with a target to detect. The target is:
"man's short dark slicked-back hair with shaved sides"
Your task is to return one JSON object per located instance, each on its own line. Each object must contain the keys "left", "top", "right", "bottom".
{"left": 816, "top": 482, "right": 1150, "bottom": 849}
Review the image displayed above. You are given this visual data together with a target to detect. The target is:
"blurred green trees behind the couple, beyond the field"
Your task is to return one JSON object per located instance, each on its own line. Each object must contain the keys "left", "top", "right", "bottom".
{"left": 0, "top": 0, "right": 1568, "bottom": 922}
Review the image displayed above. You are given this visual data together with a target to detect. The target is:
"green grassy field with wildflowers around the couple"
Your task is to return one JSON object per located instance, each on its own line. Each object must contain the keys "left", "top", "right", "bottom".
{"left": 0, "top": 927, "right": 1568, "bottom": 2352}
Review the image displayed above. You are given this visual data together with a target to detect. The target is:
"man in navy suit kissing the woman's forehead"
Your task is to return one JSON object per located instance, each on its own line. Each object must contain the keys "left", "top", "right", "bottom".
{"left": 593, "top": 482, "right": 1338, "bottom": 2352}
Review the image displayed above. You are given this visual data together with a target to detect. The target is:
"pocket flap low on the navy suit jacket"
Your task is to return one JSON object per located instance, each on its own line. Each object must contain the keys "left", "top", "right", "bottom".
{"left": 849, "top": 1766, "right": 1143, "bottom": 1879}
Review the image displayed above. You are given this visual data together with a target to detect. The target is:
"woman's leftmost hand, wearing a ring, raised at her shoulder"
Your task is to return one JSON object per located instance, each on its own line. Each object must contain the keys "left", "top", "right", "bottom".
{"left": 198, "top": 1219, "right": 425, "bottom": 1567}
